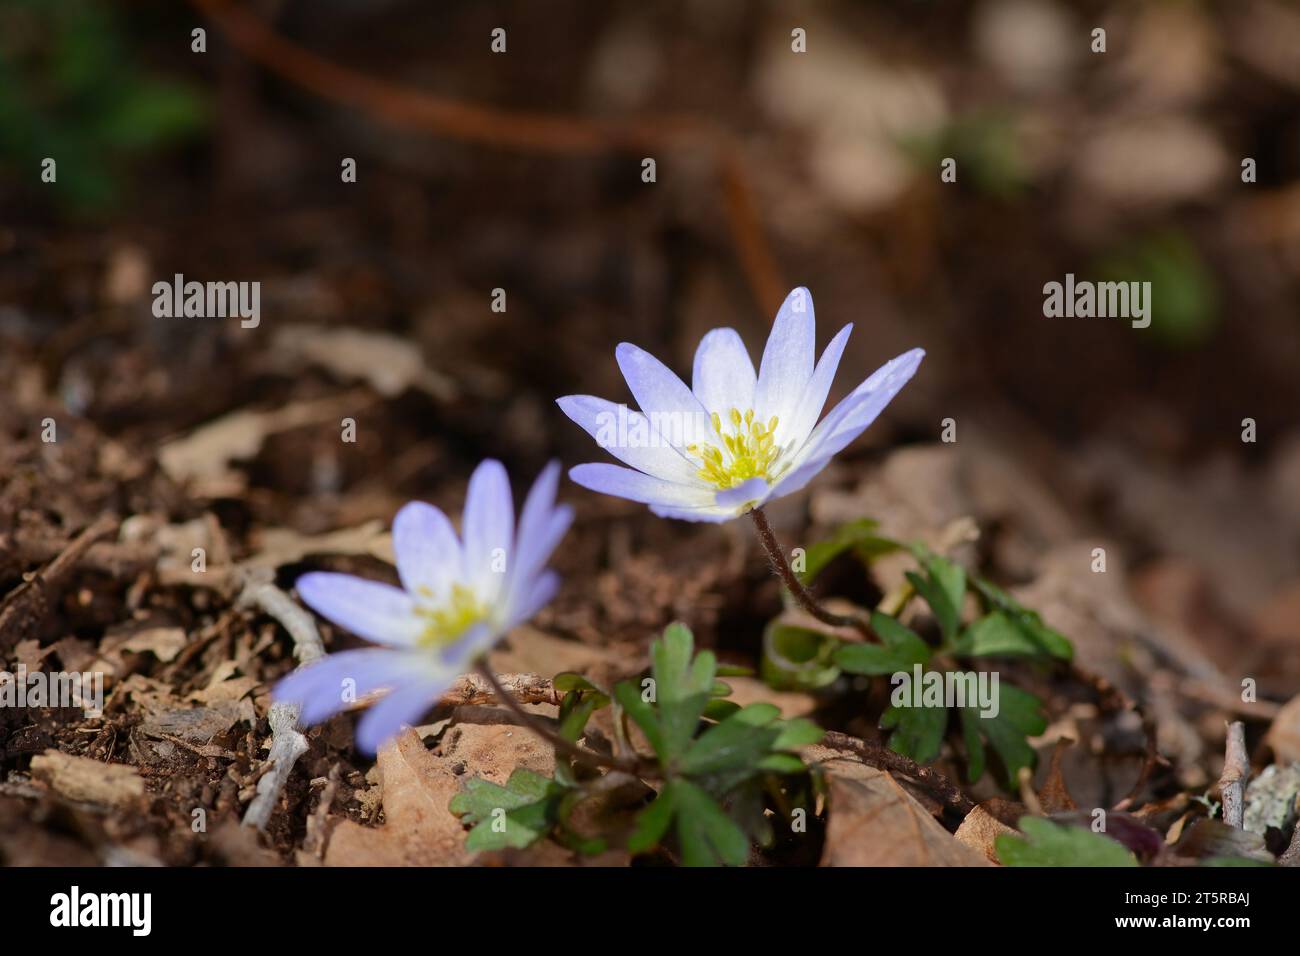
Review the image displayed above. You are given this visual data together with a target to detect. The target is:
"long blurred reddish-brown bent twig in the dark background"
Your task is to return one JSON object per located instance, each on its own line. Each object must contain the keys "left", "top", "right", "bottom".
{"left": 191, "top": 0, "right": 784, "bottom": 315}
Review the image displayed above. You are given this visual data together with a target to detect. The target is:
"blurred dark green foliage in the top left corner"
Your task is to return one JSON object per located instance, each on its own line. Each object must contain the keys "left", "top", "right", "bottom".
{"left": 0, "top": 0, "right": 207, "bottom": 213}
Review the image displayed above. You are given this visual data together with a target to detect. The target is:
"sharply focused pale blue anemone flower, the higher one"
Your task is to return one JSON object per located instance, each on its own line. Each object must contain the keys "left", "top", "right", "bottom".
{"left": 558, "top": 289, "right": 926, "bottom": 522}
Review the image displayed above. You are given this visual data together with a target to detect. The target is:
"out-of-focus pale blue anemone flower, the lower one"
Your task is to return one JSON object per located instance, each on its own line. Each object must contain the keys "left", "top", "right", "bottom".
{"left": 274, "top": 460, "right": 573, "bottom": 753}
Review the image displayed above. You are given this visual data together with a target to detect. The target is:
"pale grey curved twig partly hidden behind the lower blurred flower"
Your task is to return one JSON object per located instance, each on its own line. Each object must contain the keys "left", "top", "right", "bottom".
{"left": 237, "top": 572, "right": 325, "bottom": 830}
